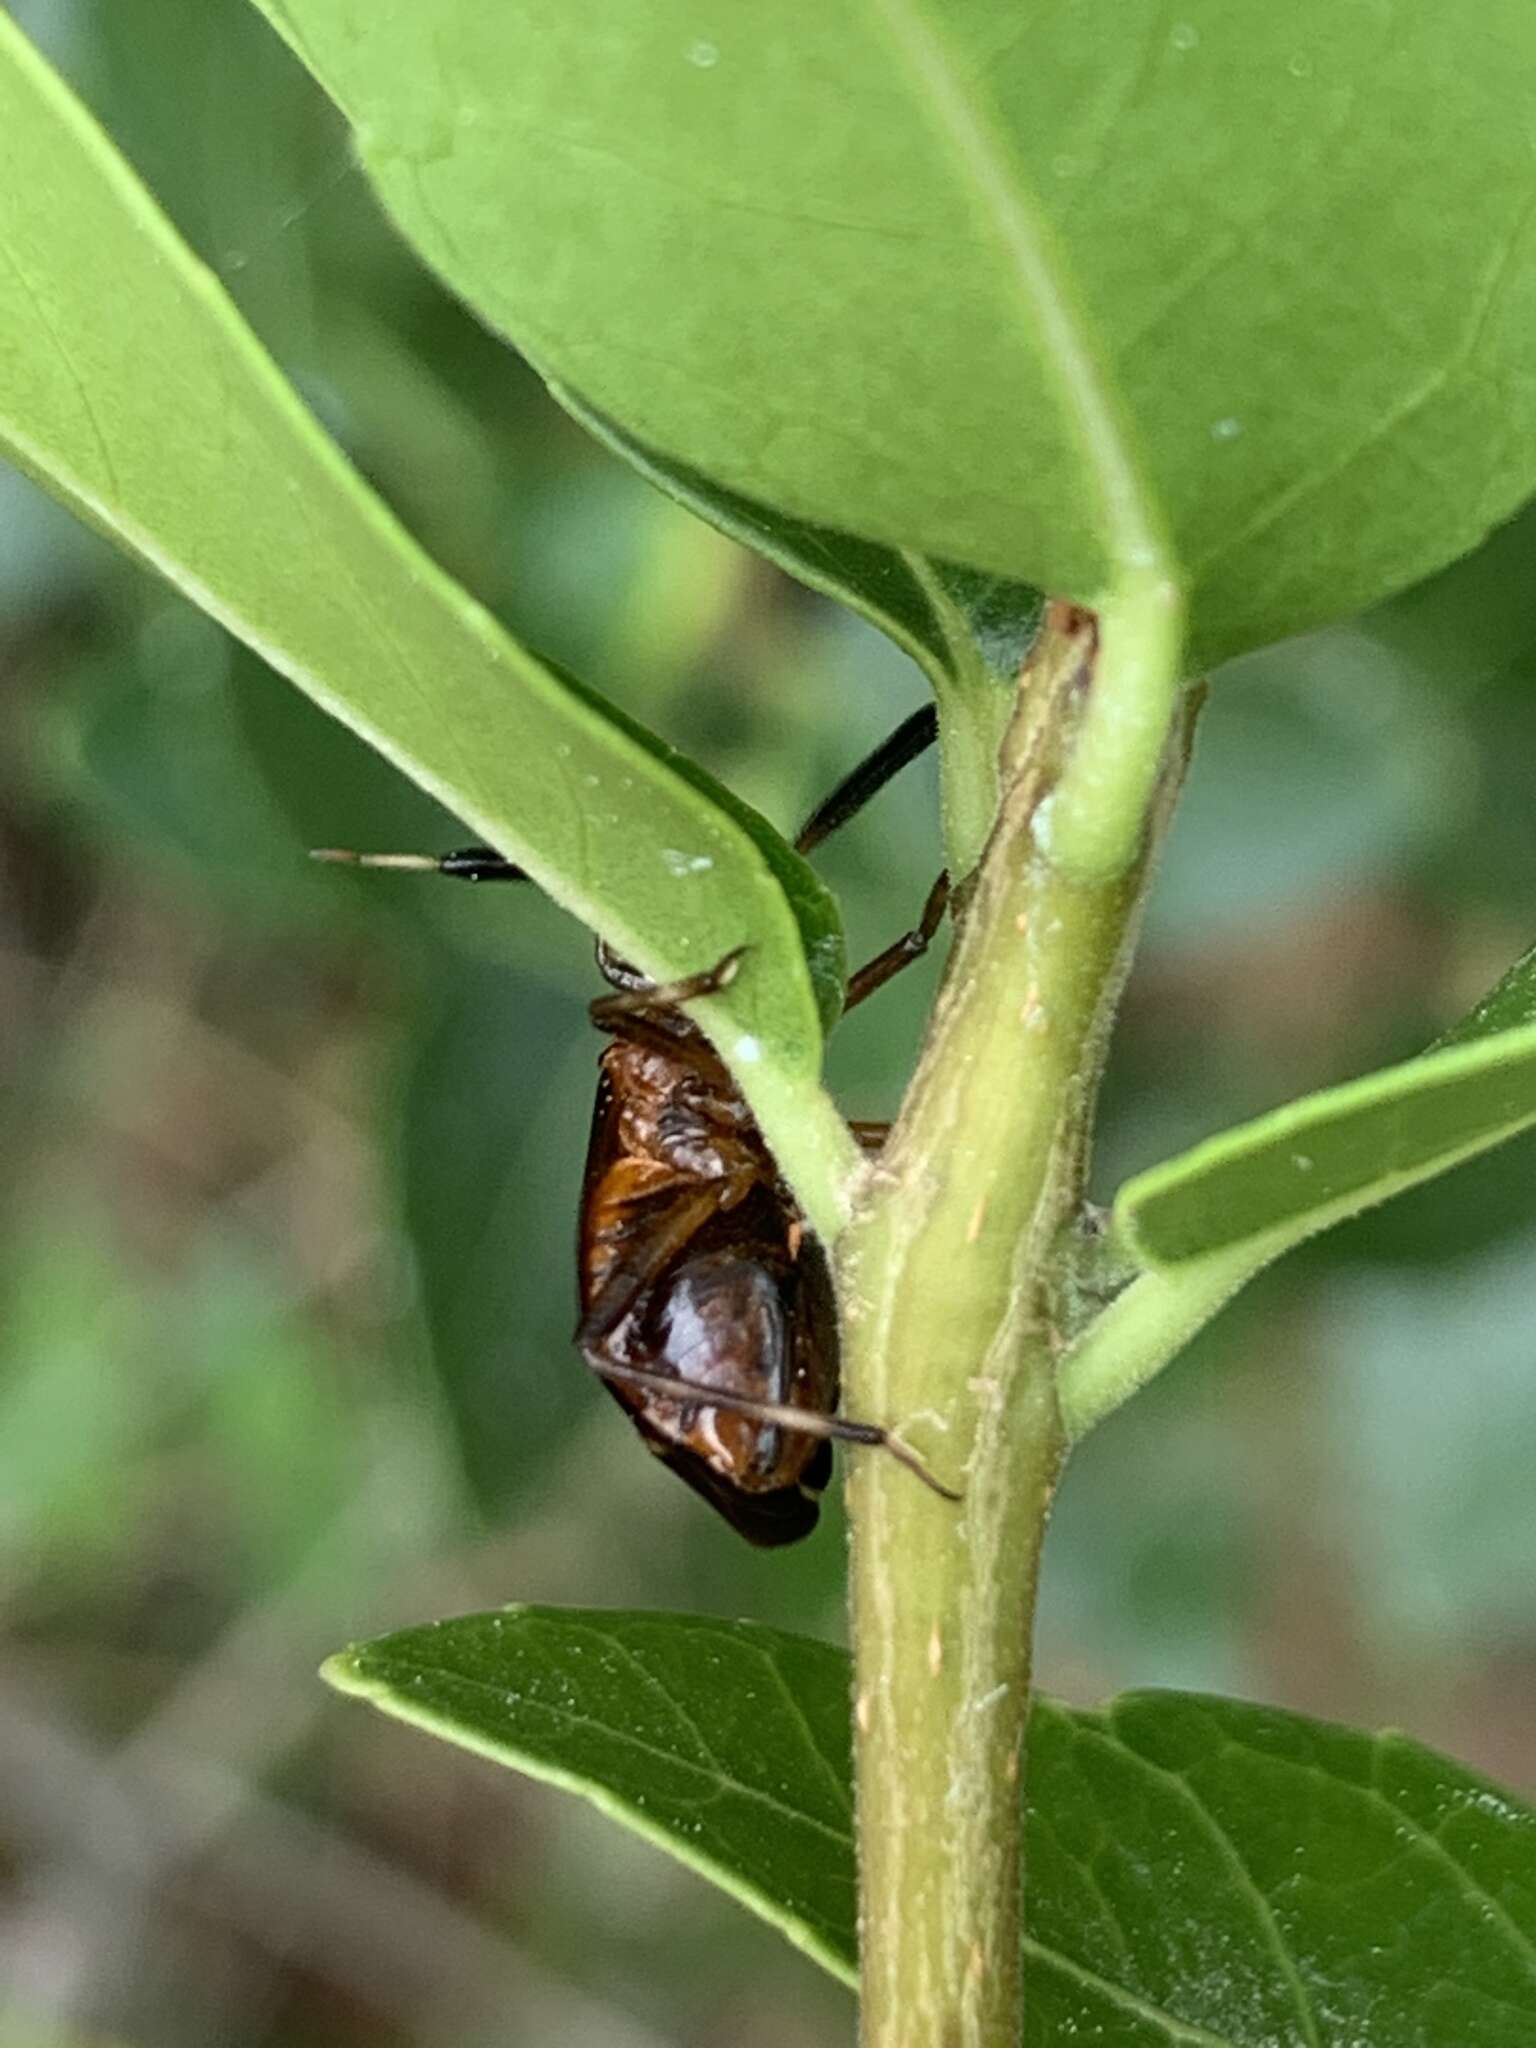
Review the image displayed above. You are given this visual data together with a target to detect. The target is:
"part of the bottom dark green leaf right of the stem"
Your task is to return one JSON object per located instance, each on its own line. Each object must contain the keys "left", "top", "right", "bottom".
{"left": 1028, "top": 1692, "right": 1536, "bottom": 2048}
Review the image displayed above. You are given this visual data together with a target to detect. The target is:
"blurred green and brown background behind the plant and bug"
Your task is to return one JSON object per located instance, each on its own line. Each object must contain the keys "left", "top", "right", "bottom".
{"left": 0, "top": 0, "right": 1536, "bottom": 2048}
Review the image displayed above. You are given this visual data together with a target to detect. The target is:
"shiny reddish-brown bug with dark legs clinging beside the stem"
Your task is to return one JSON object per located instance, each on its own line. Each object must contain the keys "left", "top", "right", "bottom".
{"left": 315, "top": 707, "right": 948, "bottom": 1546}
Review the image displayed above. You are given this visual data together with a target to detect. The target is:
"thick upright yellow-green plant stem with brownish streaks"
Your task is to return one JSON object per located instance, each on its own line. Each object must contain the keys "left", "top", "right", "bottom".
{"left": 840, "top": 606, "right": 1184, "bottom": 2048}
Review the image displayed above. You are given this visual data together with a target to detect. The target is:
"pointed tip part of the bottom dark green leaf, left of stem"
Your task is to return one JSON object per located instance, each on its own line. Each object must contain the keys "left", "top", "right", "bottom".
{"left": 324, "top": 1608, "right": 868, "bottom": 1982}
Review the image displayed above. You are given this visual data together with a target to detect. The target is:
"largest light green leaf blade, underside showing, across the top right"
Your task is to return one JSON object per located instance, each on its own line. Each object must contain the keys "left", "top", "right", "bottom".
{"left": 246, "top": 0, "right": 1536, "bottom": 664}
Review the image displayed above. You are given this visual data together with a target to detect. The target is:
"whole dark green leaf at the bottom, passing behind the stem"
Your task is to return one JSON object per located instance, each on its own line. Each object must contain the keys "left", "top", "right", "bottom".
{"left": 326, "top": 1608, "right": 1536, "bottom": 2048}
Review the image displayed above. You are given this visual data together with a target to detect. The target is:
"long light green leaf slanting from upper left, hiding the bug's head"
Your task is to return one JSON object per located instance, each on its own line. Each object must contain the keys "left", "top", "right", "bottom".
{"left": 0, "top": 14, "right": 850, "bottom": 1227}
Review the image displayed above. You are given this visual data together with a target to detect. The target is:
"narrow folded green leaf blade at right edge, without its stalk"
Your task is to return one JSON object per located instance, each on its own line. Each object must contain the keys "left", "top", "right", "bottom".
{"left": 1114, "top": 948, "right": 1536, "bottom": 1268}
